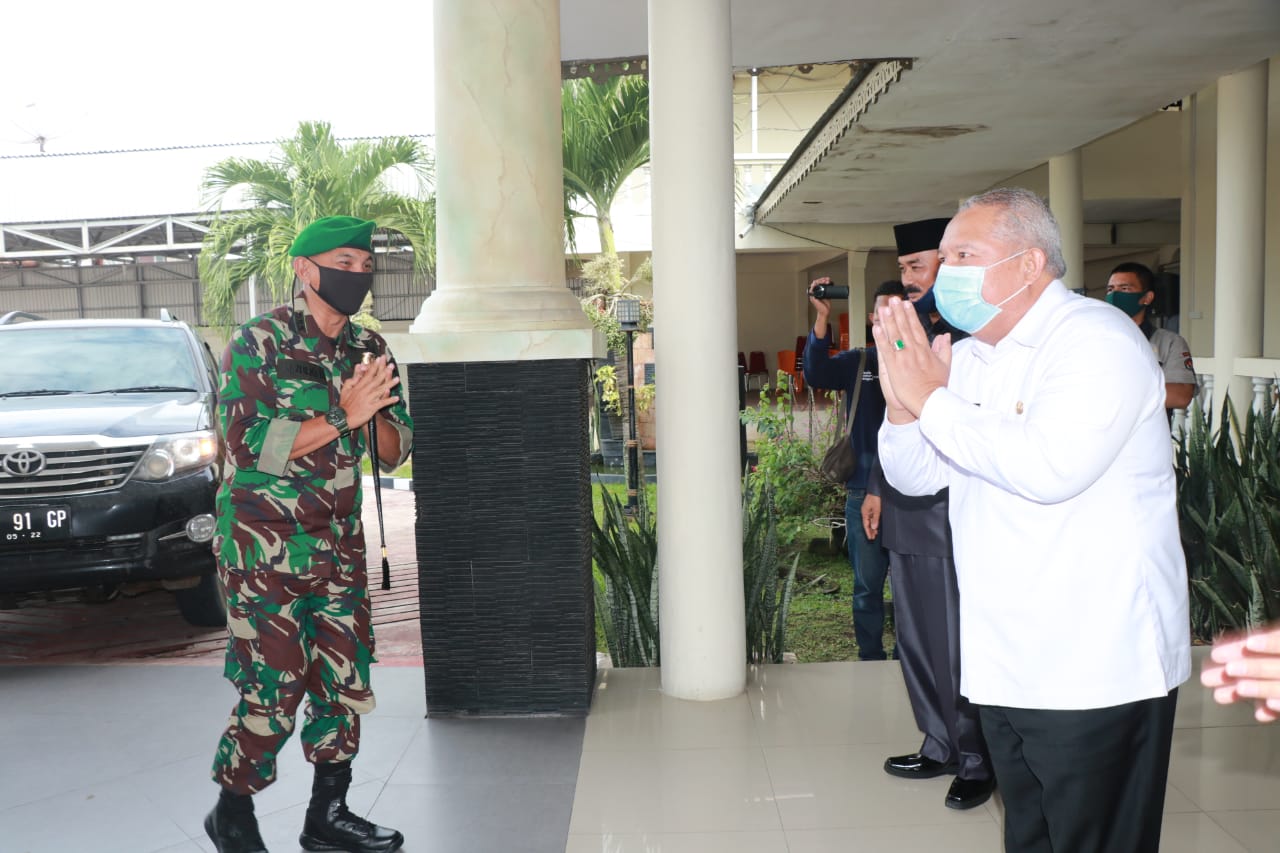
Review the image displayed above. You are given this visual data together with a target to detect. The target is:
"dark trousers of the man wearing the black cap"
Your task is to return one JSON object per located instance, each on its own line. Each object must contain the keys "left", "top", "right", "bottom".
{"left": 888, "top": 552, "right": 992, "bottom": 779}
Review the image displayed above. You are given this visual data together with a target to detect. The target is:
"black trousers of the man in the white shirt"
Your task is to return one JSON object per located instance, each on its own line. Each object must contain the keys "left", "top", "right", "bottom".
{"left": 980, "top": 688, "right": 1178, "bottom": 853}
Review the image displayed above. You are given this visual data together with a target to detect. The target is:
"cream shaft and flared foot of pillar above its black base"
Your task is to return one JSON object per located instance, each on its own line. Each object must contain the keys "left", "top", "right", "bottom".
{"left": 392, "top": 0, "right": 595, "bottom": 362}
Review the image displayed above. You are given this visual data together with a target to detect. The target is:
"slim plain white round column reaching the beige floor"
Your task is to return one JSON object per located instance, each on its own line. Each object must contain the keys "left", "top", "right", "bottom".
{"left": 649, "top": 0, "right": 746, "bottom": 699}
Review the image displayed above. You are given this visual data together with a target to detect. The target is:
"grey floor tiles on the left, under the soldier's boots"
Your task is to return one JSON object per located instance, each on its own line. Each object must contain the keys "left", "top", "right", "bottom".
{"left": 0, "top": 666, "right": 585, "bottom": 853}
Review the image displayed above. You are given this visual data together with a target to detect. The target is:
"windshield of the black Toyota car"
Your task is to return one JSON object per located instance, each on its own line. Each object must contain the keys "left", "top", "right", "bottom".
{"left": 0, "top": 325, "right": 200, "bottom": 397}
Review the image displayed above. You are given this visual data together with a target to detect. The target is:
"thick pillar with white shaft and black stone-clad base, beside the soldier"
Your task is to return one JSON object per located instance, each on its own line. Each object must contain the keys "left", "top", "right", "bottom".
{"left": 388, "top": 0, "right": 598, "bottom": 716}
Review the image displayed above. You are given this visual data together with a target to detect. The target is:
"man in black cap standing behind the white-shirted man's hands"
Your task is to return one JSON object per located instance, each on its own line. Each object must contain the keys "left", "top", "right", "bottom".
{"left": 864, "top": 219, "right": 995, "bottom": 809}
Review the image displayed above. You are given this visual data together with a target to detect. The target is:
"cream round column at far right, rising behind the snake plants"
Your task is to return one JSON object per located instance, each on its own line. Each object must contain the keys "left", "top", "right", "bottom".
{"left": 1213, "top": 61, "right": 1267, "bottom": 416}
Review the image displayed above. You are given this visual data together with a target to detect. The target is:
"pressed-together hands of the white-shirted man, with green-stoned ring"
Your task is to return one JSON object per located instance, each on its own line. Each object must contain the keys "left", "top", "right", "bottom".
{"left": 872, "top": 297, "right": 951, "bottom": 424}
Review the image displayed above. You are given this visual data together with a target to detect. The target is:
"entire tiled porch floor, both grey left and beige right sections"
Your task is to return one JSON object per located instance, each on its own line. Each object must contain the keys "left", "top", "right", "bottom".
{"left": 0, "top": 649, "right": 1280, "bottom": 853}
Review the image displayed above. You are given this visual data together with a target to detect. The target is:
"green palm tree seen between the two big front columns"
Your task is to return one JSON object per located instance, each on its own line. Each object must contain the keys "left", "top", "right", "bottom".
{"left": 561, "top": 76, "right": 649, "bottom": 255}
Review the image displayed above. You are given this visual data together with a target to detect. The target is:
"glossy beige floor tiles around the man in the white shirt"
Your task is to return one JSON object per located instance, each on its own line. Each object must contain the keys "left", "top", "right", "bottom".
{"left": 576, "top": 648, "right": 1280, "bottom": 853}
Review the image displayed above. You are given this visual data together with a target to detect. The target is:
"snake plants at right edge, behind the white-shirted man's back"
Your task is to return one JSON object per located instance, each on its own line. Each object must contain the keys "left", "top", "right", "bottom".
{"left": 1176, "top": 398, "right": 1280, "bottom": 642}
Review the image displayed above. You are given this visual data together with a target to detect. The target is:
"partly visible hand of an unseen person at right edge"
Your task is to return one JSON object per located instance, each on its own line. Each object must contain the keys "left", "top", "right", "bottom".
{"left": 1201, "top": 624, "right": 1280, "bottom": 722}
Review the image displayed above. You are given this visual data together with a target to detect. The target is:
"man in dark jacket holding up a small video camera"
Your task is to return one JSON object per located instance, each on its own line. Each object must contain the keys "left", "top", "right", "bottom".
{"left": 804, "top": 278, "right": 906, "bottom": 661}
